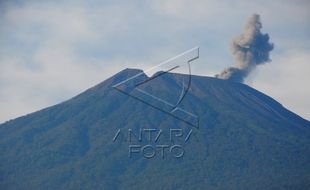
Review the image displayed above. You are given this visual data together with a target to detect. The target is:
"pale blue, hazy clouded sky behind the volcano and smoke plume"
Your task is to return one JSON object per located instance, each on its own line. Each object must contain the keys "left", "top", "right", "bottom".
{"left": 0, "top": 0, "right": 310, "bottom": 123}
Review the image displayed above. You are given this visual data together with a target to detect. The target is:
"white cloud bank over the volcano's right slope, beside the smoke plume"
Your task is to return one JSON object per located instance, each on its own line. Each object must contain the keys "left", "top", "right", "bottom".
{"left": 248, "top": 49, "right": 310, "bottom": 119}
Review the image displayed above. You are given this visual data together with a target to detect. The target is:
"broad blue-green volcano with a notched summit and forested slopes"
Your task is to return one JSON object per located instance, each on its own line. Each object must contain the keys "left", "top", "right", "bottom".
{"left": 0, "top": 69, "right": 310, "bottom": 190}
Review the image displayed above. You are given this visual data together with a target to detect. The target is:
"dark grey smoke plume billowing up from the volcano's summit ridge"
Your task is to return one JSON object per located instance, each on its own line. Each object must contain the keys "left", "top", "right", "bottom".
{"left": 216, "top": 14, "right": 274, "bottom": 82}
